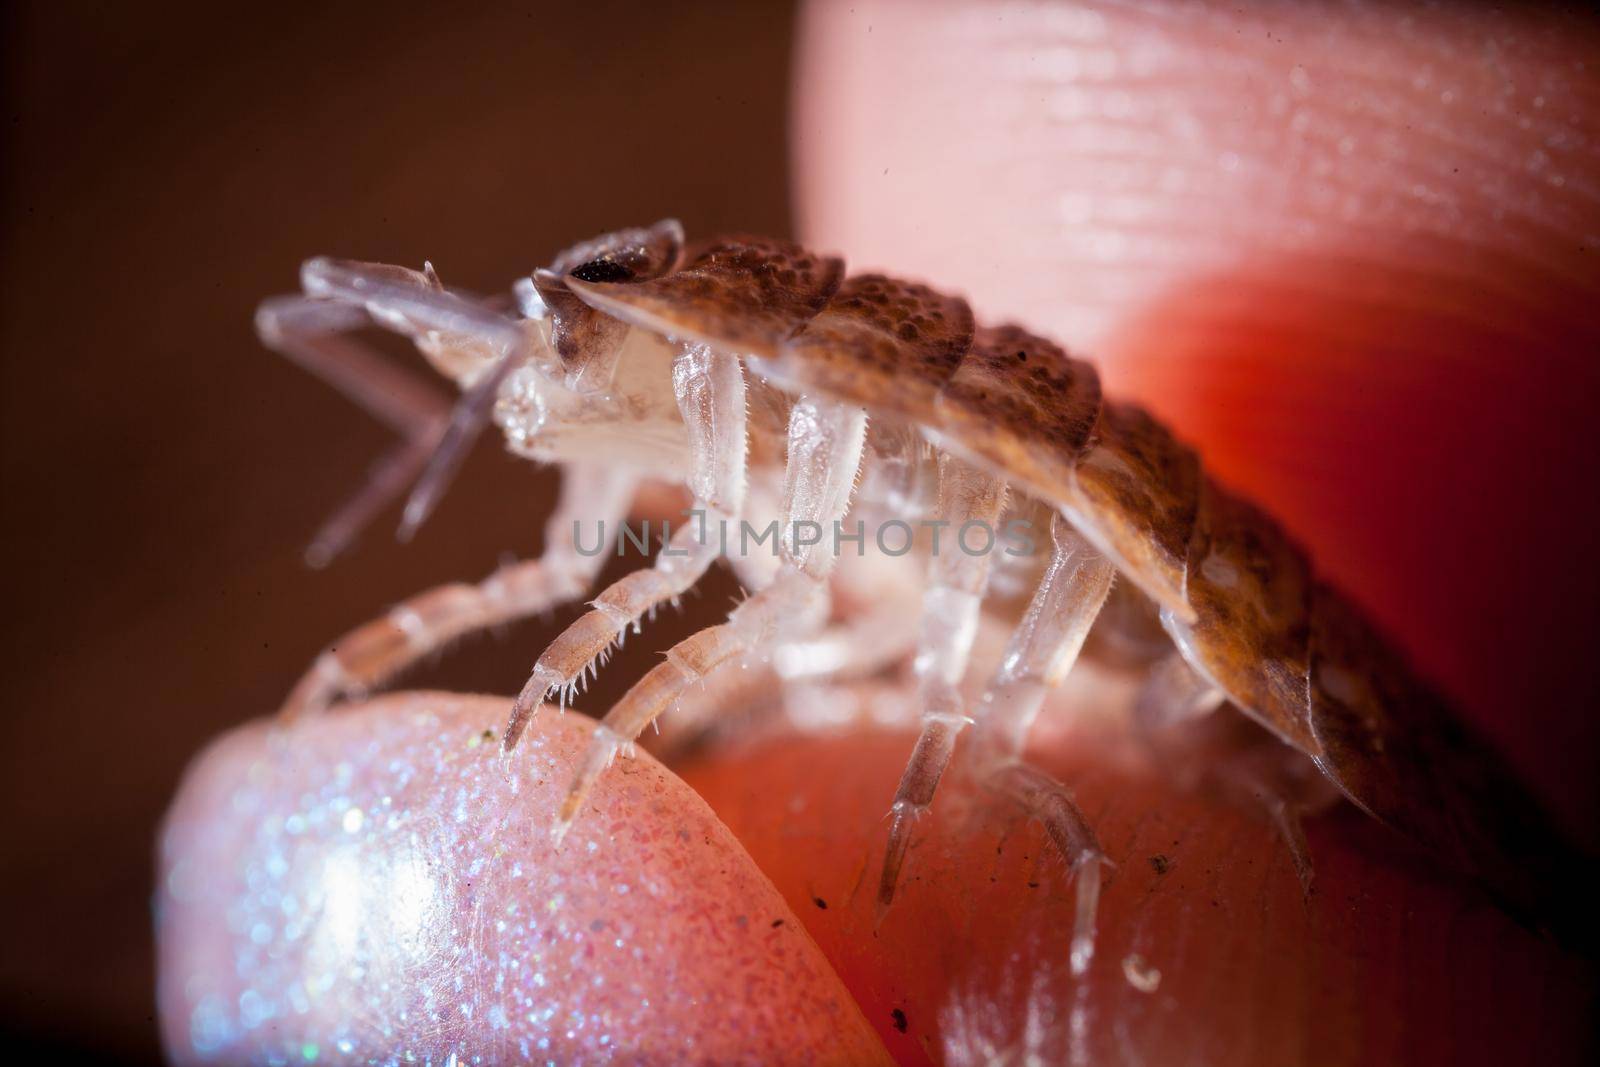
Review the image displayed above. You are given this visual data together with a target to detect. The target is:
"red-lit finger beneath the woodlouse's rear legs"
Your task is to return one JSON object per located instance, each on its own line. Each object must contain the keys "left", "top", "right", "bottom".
{"left": 682, "top": 718, "right": 1594, "bottom": 1067}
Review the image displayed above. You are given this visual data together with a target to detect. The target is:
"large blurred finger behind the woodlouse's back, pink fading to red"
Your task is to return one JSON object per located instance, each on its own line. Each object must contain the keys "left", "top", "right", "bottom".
{"left": 794, "top": 0, "right": 1600, "bottom": 841}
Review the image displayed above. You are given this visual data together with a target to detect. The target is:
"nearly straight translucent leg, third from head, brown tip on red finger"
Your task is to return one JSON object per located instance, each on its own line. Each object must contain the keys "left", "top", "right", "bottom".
{"left": 878, "top": 453, "right": 1006, "bottom": 907}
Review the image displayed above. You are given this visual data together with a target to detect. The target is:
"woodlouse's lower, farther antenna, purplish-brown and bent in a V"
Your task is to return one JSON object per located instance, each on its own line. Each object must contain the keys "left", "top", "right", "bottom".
{"left": 256, "top": 296, "right": 450, "bottom": 568}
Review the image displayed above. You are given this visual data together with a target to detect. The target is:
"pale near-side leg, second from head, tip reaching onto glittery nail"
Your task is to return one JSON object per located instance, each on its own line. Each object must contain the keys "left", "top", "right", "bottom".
{"left": 555, "top": 397, "right": 867, "bottom": 840}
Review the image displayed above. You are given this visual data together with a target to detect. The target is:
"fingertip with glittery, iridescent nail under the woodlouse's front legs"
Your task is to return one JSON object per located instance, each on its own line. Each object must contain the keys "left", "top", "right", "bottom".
{"left": 157, "top": 693, "right": 888, "bottom": 1064}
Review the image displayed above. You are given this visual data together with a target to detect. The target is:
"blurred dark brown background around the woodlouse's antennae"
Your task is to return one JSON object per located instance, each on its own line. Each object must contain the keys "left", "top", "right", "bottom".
{"left": 0, "top": 2, "right": 792, "bottom": 1062}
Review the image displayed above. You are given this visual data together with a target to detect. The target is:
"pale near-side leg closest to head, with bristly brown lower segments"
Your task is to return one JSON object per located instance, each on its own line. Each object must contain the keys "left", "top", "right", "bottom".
{"left": 501, "top": 344, "right": 747, "bottom": 752}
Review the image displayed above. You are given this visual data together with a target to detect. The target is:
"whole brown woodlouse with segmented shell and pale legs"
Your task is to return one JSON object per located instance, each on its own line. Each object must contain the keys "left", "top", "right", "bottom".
{"left": 258, "top": 221, "right": 1554, "bottom": 950}
